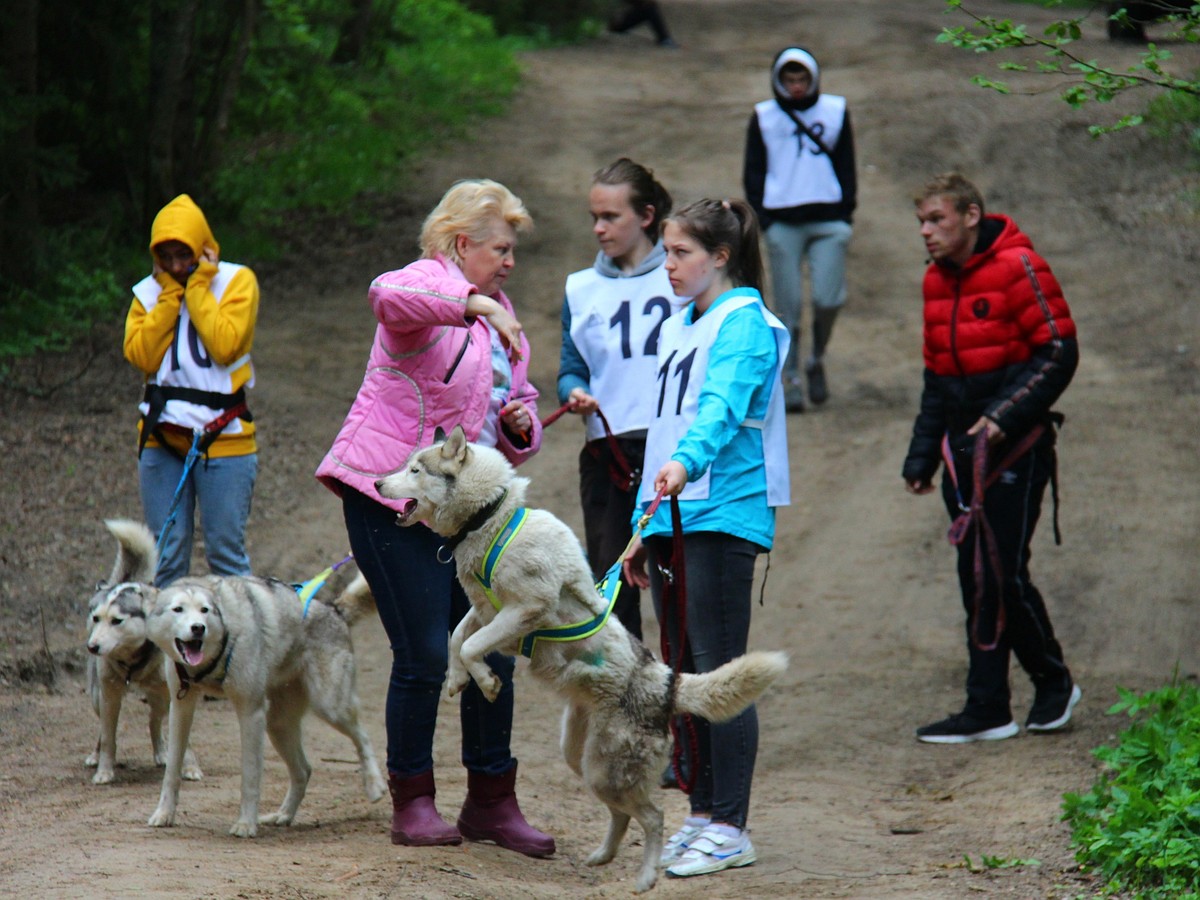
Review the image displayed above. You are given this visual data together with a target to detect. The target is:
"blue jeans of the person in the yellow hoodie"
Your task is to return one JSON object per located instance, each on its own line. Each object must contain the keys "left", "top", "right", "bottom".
{"left": 138, "top": 446, "right": 258, "bottom": 587}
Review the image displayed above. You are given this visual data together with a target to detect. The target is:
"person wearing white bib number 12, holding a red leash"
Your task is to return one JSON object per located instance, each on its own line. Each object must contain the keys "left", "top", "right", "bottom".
{"left": 558, "top": 157, "right": 684, "bottom": 640}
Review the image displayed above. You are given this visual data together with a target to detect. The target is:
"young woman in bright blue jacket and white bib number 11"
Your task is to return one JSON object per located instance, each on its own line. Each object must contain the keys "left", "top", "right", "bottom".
{"left": 625, "top": 200, "right": 791, "bottom": 877}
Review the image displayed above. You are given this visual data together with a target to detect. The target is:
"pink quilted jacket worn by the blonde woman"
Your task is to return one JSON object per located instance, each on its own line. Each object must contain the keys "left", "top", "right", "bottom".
{"left": 317, "top": 254, "right": 541, "bottom": 510}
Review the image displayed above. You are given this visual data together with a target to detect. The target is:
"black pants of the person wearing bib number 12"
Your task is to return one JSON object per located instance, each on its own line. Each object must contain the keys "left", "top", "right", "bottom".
{"left": 580, "top": 438, "right": 646, "bottom": 641}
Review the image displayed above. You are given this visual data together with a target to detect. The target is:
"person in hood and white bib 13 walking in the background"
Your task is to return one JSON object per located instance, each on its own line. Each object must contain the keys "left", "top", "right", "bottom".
{"left": 742, "top": 47, "right": 858, "bottom": 413}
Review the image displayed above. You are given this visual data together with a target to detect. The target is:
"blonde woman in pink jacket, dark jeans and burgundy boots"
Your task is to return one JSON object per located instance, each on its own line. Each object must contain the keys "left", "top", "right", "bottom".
{"left": 317, "top": 180, "right": 554, "bottom": 857}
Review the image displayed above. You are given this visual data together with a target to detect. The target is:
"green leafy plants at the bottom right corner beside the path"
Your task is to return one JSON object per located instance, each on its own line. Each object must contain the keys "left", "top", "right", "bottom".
{"left": 1063, "top": 679, "right": 1200, "bottom": 900}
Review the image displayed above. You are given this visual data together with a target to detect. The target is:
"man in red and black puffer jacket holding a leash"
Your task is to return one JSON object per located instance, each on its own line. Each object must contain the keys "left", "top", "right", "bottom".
{"left": 904, "top": 173, "right": 1080, "bottom": 744}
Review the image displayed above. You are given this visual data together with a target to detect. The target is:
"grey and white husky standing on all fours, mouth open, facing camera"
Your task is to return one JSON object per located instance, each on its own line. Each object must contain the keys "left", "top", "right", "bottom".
{"left": 101, "top": 522, "right": 388, "bottom": 838}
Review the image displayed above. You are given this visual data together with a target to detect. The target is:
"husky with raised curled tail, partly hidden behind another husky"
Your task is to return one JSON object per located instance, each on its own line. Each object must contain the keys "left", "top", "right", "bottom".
{"left": 84, "top": 521, "right": 204, "bottom": 785}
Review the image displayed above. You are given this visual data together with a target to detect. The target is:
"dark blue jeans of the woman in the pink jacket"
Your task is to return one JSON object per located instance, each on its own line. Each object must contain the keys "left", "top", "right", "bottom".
{"left": 342, "top": 485, "right": 516, "bottom": 776}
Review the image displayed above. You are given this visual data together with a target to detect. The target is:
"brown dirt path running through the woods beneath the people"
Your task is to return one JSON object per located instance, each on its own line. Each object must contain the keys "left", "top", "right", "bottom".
{"left": 0, "top": 0, "right": 1200, "bottom": 899}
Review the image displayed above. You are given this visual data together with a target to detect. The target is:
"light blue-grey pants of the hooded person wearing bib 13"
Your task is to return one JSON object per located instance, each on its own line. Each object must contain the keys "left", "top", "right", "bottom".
{"left": 766, "top": 220, "right": 853, "bottom": 379}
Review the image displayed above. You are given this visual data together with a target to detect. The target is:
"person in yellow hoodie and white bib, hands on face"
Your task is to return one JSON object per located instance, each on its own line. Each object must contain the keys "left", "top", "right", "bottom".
{"left": 125, "top": 193, "right": 258, "bottom": 586}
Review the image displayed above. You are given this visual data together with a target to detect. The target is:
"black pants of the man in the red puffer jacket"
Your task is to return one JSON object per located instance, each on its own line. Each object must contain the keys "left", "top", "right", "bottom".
{"left": 942, "top": 448, "right": 1072, "bottom": 721}
